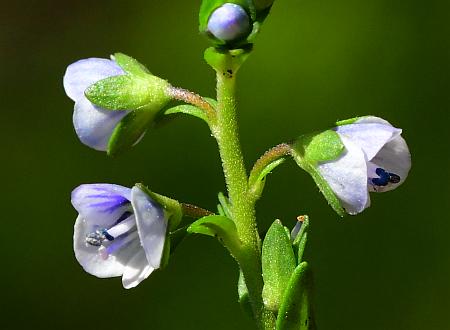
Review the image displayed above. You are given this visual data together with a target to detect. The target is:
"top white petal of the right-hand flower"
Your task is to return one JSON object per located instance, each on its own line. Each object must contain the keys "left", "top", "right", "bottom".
{"left": 336, "top": 123, "right": 402, "bottom": 160}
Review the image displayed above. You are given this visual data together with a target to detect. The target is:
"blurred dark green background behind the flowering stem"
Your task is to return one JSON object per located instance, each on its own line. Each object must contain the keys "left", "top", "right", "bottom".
{"left": 0, "top": 0, "right": 450, "bottom": 330}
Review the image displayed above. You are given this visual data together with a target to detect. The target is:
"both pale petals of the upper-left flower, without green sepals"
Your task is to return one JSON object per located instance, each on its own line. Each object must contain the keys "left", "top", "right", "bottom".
{"left": 63, "top": 58, "right": 128, "bottom": 151}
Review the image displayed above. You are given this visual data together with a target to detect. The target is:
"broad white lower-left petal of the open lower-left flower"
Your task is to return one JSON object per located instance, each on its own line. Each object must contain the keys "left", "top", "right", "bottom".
{"left": 73, "top": 215, "right": 142, "bottom": 278}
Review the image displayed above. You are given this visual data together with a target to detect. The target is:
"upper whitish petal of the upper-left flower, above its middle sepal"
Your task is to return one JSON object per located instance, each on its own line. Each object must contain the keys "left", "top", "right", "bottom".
{"left": 63, "top": 58, "right": 125, "bottom": 102}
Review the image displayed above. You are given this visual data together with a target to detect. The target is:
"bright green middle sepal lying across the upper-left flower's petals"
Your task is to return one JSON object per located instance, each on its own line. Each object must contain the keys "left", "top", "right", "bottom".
{"left": 84, "top": 74, "right": 171, "bottom": 110}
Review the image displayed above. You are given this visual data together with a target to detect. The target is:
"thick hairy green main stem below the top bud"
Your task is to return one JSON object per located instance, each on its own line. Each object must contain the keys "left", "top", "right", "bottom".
{"left": 213, "top": 71, "right": 275, "bottom": 330}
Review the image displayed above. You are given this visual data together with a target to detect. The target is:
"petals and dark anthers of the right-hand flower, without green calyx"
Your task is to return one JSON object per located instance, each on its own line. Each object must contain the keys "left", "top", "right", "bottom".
{"left": 318, "top": 116, "right": 411, "bottom": 214}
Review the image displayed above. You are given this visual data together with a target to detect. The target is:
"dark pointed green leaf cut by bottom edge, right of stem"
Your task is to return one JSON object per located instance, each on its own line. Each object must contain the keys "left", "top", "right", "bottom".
{"left": 276, "top": 261, "right": 317, "bottom": 330}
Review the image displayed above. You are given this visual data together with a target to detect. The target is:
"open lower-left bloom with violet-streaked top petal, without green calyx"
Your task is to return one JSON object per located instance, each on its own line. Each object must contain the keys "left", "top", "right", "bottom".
{"left": 72, "top": 184, "right": 168, "bottom": 289}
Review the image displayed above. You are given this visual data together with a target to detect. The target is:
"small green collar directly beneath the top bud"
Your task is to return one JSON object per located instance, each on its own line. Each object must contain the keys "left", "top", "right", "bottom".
{"left": 204, "top": 47, "right": 251, "bottom": 78}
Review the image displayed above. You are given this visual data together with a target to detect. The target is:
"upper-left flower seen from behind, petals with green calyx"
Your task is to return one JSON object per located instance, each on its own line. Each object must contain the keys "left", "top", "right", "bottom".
{"left": 64, "top": 53, "right": 172, "bottom": 155}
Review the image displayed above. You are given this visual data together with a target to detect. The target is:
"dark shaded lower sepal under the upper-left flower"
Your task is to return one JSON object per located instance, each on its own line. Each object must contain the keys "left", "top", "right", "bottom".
{"left": 107, "top": 107, "right": 156, "bottom": 156}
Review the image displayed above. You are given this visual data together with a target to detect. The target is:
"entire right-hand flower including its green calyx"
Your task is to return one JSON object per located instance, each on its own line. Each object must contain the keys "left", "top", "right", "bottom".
{"left": 293, "top": 116, "right": 411, "bottom": 214}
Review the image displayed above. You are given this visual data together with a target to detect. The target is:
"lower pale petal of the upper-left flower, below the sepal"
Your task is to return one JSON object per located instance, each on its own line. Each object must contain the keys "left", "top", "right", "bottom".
{"left": 73, "top": 97, "right": 128, "bottom": 151}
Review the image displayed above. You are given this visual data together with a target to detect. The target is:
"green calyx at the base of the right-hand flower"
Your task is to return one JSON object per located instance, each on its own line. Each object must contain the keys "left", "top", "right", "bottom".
{"left": 291, "top": 130, "right": 345, "bottom": 217}
